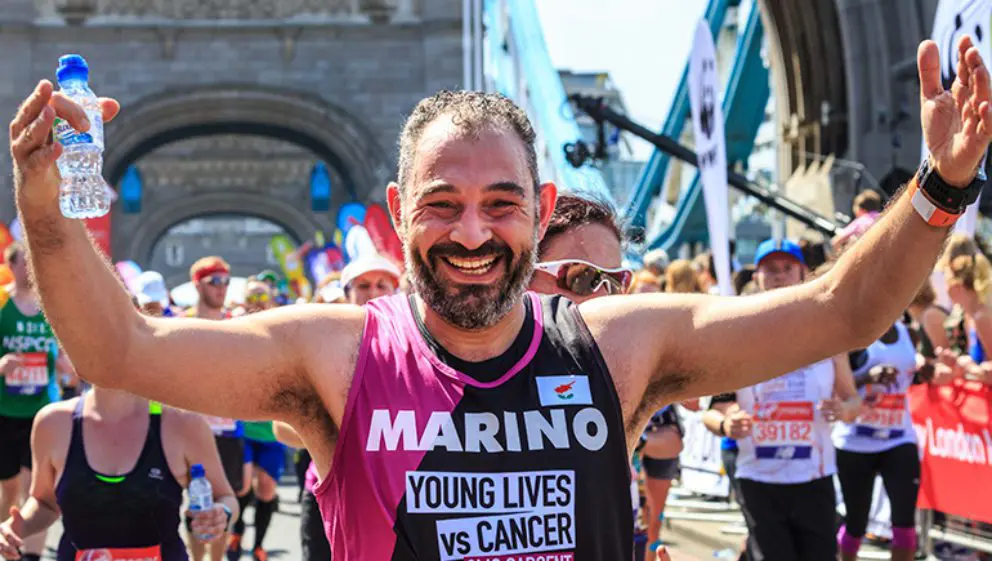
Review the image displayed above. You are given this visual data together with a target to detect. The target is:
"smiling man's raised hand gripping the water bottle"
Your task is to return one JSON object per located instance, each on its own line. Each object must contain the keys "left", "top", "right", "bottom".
{"left": 10, "top": 80, "right": 120, "bottom": 211}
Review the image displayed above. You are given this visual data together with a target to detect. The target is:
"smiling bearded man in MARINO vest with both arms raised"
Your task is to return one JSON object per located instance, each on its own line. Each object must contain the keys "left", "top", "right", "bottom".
{"left": 10, "top": 40, "right": 992, "bottom": 561}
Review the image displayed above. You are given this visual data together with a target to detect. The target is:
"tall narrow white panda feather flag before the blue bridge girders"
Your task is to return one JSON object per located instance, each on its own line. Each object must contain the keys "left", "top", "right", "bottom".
{"left": 689, "top": 20, "right": 734, "bottom": 296}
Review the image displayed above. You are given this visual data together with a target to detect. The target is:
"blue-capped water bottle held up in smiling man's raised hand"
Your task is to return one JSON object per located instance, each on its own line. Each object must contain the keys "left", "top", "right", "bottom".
{"left": 55, "top": 55, "right": 110, "bottom": 218}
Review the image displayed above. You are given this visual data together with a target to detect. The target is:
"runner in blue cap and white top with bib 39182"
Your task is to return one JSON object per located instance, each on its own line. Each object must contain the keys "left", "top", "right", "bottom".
{"left": 713, "top": 240, "right": 860, "bottom": 561}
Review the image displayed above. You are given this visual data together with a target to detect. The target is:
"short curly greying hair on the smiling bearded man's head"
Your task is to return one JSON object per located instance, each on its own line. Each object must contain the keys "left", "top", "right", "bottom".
{"left": 399, "top": 90, "right": 541, "bottom": 196}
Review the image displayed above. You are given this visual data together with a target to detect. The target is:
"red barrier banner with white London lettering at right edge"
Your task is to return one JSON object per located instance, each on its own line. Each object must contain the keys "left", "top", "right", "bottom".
{"left": 909, "top": 381, "right": 992, "bottom": 523}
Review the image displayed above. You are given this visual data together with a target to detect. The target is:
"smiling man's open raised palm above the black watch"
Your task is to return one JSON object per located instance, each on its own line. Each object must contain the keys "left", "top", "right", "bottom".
{"left": 917, "top": 37, "right": 992, "bottom": 187}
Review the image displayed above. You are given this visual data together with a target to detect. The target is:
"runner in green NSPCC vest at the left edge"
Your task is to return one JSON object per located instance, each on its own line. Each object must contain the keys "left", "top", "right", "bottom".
{"left": 0, "top": 242, "right": 64, "bottom": 561}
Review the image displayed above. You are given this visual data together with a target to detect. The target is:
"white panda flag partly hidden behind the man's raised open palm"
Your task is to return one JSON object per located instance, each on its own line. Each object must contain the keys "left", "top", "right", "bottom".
{"left": 922, "top": 0, "right": 992, "bottom": 236}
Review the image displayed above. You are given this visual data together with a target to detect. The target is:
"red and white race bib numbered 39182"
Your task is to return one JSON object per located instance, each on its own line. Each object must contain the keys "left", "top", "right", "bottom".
{"left": 751, "top": 401, "right": 815, "bottom": 460}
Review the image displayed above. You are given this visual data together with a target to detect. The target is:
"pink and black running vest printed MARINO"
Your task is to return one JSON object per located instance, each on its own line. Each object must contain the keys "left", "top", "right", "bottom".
{"left": 314, "top": 293, "right": 633, "bottom": 561}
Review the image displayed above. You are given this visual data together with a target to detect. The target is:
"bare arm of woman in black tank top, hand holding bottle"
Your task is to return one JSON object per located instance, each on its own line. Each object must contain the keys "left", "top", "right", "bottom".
{"left": 181, "top": 413, "right": 238, "bottom": 541}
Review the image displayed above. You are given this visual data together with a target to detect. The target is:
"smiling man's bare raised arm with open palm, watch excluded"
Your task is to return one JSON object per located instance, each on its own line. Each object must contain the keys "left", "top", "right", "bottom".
{"left": 581, "top": 39, "right": 992, "bottom": 406}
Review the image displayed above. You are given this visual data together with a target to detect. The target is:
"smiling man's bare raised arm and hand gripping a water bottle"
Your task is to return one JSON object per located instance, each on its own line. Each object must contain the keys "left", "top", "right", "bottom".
{"left": 10, "top": 81, "right": 364, "bottom": 422}
